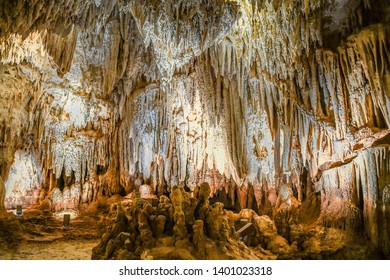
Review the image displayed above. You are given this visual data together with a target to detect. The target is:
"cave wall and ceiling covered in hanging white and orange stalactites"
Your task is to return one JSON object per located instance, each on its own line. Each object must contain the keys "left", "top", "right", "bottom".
{"left": 0, "top": 0, "right": 390, "bottom": 253}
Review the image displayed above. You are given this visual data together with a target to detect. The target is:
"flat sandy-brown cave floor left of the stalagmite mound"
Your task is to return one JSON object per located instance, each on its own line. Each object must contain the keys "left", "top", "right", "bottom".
{"left": 0, "top": 212, "right": 100, "bottom": 260}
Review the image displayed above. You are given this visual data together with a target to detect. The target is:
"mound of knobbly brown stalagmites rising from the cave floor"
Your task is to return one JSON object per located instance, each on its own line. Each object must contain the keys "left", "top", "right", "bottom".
{"left": 92, "top": 183, "right": 354, "bottom": 259}
